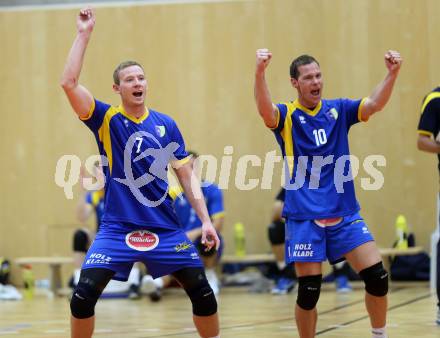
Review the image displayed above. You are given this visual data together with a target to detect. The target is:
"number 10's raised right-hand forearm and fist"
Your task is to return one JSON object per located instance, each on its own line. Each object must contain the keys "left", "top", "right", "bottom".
{"left": 361, "top": 50, "right": 403, "bottom": 121}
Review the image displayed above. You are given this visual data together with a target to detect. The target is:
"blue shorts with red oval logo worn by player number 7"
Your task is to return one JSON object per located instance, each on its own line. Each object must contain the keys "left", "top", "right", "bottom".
{"left": 82, "top": 223, "right": 203, "bottom": 281}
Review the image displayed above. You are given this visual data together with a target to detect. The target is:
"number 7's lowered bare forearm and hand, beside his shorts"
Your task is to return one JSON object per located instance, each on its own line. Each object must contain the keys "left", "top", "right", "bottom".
{"left": 174, "top": 162, "right": 220, "bottom": 250}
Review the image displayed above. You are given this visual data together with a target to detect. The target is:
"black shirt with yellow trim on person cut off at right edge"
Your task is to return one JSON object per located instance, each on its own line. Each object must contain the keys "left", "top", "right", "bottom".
{"left": 418, "top": 87, "right": 440, "bottom": 172}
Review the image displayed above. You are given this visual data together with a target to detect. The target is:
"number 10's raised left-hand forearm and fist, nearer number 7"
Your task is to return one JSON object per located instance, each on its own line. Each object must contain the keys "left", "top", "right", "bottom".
{"left": 254, "top": 48, "right": 278, "bottom": 128}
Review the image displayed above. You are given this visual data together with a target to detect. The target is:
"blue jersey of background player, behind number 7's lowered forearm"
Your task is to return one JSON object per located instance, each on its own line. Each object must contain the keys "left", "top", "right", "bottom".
{"left": 170, "top": 182, "right": 225, "bottom": 231}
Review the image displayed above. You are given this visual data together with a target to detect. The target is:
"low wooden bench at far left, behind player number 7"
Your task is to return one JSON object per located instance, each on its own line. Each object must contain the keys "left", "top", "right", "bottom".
{"left": 15, "top": 257, "right": 73, "bottom": 295}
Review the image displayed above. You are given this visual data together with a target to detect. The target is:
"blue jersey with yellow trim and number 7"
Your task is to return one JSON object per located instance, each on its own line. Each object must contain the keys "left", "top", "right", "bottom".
{"left": 82, "top": 100, "right": 190, "bottom": 229}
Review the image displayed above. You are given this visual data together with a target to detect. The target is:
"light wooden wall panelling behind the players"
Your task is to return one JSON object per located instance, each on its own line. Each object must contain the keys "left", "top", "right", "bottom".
{"left": 0, "top": 0, "right": 440, "bottom": 282}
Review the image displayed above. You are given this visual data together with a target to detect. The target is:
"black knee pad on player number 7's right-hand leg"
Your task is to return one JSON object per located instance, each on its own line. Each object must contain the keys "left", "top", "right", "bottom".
{"left": 185, "top": 277, "right": 217, "bottom": 317}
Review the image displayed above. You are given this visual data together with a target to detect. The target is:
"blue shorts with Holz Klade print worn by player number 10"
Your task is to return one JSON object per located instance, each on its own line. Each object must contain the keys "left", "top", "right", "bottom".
{"left": 285, "top": 213, "right": 374, "bottom": 264}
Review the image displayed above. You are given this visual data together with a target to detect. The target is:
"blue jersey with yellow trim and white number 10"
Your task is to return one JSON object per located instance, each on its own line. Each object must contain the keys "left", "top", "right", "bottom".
{"left": 273, "top": 99, "right": 364, "bottom": 220}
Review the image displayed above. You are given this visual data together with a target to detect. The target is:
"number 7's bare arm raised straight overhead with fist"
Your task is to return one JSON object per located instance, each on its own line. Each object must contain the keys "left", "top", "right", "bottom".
{"left": 61, "top": 7, "right": 95, "bottom": 118}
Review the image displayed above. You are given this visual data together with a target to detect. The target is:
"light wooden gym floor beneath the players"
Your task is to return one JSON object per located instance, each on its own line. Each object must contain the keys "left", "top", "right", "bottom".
{"left": 0, "top": 283, "right": 440, "bottom": 338}
